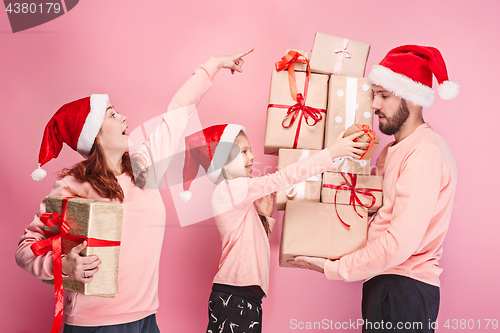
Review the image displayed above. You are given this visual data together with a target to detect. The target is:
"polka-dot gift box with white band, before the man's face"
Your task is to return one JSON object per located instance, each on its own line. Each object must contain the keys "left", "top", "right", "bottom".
{"left": 325, "top": 75, "right": 373, "bottom": 147}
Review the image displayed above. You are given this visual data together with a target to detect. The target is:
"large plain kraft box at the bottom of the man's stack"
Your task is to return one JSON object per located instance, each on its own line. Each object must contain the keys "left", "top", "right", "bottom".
{"left": 279, "top": 201, "right": 368, "bottom": 267}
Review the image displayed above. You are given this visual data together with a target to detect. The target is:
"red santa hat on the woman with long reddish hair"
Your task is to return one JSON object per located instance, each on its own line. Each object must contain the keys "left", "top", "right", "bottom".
{"left": 31, "top": 94, "right": 109, "bottom": 181}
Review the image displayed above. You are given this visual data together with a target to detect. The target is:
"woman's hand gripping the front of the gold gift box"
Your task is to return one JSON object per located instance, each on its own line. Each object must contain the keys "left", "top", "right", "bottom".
{"left": 62, "top": 241, "right": 102, "bottom": 283}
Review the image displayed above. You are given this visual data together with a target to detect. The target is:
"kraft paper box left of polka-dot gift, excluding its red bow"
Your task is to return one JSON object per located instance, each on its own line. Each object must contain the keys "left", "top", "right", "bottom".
{"left": 264, "top": 70, "right": 329, "bottom": 155}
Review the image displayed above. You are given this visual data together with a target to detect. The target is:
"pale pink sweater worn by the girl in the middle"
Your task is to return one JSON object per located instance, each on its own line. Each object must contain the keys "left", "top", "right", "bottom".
{"left": 212, "top": 149, "right": 334, "bottom": 295}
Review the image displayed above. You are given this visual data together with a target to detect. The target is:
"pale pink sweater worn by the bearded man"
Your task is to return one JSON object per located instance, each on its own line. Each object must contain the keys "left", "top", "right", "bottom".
{"left": 324, "top": 124, "right": 457, "bottom": 286}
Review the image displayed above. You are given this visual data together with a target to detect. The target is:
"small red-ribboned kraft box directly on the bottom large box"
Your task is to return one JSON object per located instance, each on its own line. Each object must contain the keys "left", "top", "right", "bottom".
{"left": 321, "top": 172, "right": 383, "bottom": 212}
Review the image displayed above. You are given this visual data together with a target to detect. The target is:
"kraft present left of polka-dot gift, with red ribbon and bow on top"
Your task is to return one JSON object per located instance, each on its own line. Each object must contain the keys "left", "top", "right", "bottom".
{"left": 264, "top": 51, "right": 329, "bottom": 155}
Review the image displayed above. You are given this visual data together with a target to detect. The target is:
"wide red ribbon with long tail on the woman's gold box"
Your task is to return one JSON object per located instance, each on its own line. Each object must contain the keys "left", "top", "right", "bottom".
{"left": 30, "top": 197, "right": 120, "bottom": 333}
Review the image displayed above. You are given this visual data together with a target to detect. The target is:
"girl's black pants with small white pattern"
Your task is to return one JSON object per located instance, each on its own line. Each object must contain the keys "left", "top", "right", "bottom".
{"left": 207, "top": 290, "right": 262, "bottom": 333}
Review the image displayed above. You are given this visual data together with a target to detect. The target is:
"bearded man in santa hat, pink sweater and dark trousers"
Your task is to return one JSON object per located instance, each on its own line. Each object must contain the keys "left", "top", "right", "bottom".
{"left": 291, "top": 45, "right": 459, "bottom": 332}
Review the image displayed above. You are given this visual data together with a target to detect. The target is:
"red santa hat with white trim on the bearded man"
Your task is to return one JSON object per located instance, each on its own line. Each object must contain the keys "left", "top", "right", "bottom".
{"left": 368, "top": 45, "right": 460, "bottom": 107}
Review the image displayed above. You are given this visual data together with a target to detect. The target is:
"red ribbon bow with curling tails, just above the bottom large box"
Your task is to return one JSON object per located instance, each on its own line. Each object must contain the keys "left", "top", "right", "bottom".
{"left": 323, "top": 172, "right": 382, "bottom": 228}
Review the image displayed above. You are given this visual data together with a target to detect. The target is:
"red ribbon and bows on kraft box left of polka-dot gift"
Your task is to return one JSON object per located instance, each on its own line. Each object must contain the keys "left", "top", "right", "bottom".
{"left": 268, "top": 50, "right": 326, "bottom": 149}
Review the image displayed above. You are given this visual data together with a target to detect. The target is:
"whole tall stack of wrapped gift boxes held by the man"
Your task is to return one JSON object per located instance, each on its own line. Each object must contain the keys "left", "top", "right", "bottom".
{"left": 264, "top": 33, "right": 382, "bottom": 267}
